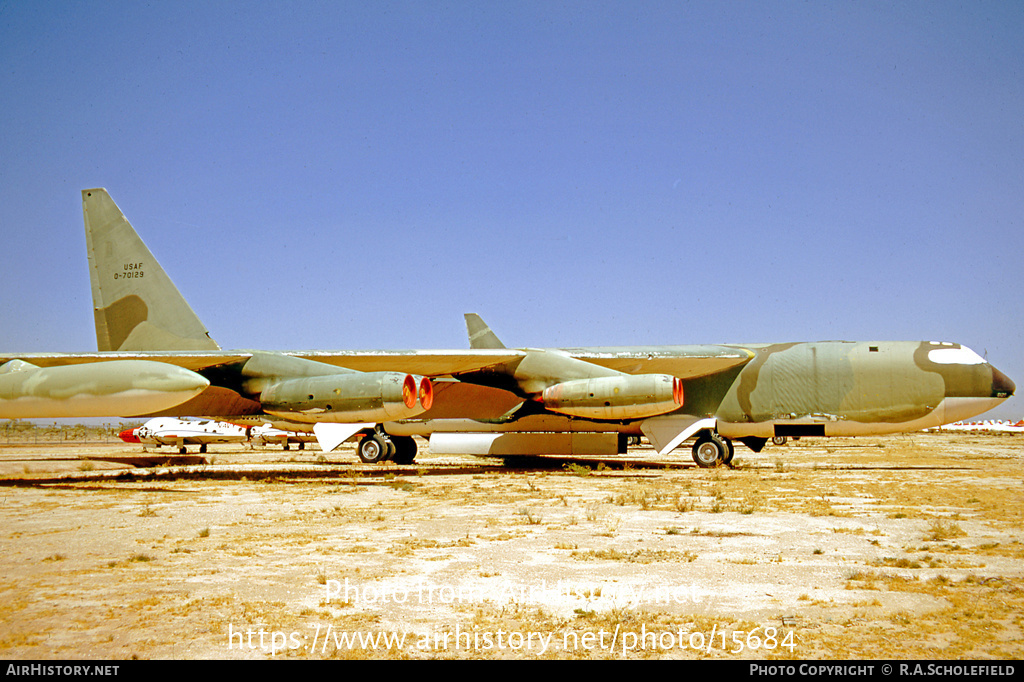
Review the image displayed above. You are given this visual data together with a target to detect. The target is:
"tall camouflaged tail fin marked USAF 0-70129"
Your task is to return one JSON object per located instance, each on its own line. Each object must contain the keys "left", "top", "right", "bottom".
{"left": 82, "top": 188, "right": 220, "bottom": 351}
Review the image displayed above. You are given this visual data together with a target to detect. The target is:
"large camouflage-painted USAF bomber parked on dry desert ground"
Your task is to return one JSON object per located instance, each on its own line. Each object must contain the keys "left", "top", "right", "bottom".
{"left": 0, "top": 189, "right": 1015, "bottom": 467}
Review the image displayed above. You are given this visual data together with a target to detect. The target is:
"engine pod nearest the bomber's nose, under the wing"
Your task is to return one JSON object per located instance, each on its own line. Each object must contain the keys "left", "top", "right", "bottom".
{"left": 540, "top": 374, "right": 683, "bottom": 419}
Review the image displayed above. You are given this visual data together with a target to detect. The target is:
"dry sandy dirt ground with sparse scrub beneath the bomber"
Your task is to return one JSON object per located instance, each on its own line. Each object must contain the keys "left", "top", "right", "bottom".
{"left": 0, "top": 433, "right": 1024, "bottom": 659}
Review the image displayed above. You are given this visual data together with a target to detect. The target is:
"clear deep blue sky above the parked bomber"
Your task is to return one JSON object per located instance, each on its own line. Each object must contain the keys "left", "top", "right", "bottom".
{"left": 0, "top": 0, "right": 1024, "bottom": 417}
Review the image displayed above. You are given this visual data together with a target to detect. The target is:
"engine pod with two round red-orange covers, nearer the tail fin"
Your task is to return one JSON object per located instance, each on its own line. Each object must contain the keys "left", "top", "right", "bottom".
{"left": 260, "top": 372, "right": 434, "bottom": 423}
